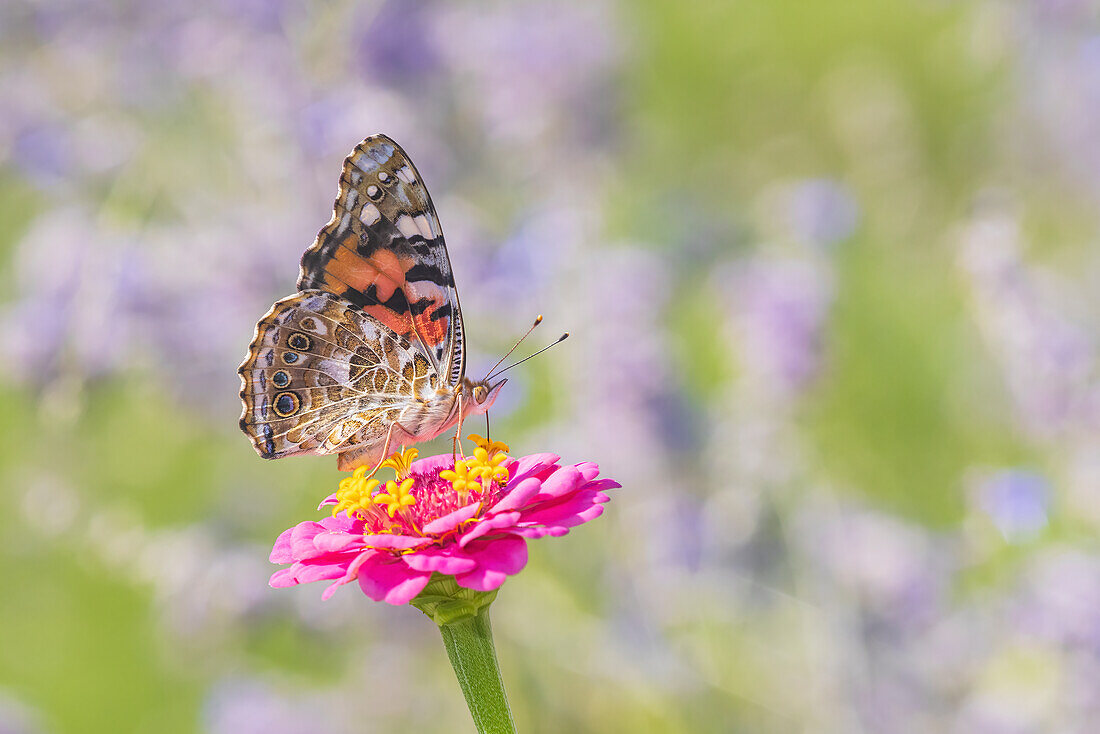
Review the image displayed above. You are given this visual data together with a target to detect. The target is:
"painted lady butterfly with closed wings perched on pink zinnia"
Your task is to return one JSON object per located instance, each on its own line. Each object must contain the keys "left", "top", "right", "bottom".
{"left": 238, "top": 135, "right": 505, "bottom": 471}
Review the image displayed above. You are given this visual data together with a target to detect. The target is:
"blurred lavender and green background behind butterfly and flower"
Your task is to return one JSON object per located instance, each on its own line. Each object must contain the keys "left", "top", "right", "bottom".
{"left": 0, "top": 0, "right": 1100, "bottom": 734}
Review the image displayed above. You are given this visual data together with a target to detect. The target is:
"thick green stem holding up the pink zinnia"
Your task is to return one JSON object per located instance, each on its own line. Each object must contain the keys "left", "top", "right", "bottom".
{"left": 411, "top": 573, "right": 516, "bottom": 734}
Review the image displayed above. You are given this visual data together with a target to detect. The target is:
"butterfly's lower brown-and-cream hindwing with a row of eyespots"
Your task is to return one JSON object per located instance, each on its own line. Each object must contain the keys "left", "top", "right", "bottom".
{"left": 239, "top": 291, "right": 439, "bottom": 459}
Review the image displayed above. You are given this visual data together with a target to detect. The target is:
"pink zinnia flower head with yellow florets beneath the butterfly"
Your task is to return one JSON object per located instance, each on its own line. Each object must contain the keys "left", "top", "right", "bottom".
{"left": 271, "top": 436, "right": 619, "bottom": 604}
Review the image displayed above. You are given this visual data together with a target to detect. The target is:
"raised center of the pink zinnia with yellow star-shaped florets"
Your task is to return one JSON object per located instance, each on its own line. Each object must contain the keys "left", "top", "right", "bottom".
{"left": 332, "top": 434, "right": 509, "bottom": 535}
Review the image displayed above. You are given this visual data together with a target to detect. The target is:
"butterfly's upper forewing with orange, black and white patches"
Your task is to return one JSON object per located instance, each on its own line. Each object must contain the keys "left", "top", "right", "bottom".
{"left": 298, "top": 135, "right": 465, "bottom": 385}
